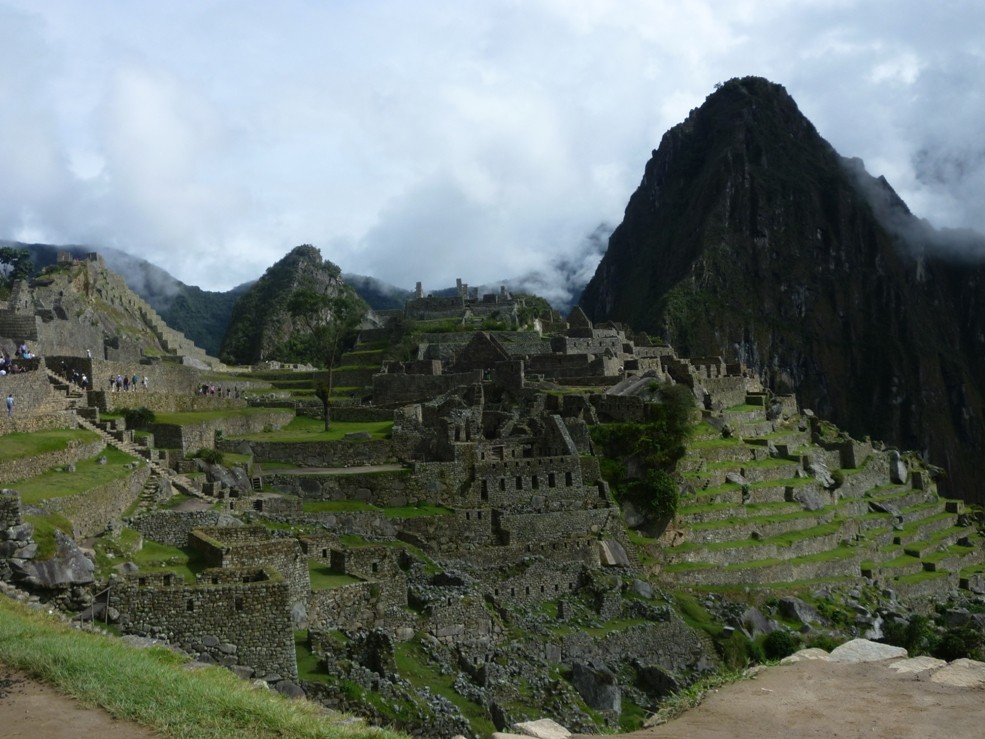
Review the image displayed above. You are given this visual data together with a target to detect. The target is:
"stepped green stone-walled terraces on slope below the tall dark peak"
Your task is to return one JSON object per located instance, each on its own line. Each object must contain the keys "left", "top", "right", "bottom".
{"left": 653, "top": 398, "right": 985, "bottom": 597}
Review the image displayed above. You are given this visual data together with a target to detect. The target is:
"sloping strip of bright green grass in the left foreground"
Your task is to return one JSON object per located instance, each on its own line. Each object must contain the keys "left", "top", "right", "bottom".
{"left": 0, "top": 598, "right": 402, "bottom": 739}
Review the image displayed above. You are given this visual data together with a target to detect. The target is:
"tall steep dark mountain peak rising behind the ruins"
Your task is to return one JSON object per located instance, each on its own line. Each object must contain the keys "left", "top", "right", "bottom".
{"left": 581, "top": 78, "right": 985, "bottom": 501}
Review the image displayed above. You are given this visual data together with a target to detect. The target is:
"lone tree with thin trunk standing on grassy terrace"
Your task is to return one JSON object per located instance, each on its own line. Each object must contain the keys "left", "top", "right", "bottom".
{"left": 287, "top": 286, "right": 366, "bottom": 431}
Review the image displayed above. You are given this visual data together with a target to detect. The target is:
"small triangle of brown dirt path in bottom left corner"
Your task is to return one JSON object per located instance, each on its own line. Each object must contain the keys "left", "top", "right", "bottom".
{"left": 0, "top": 666, "right": 160, "bottom": 739}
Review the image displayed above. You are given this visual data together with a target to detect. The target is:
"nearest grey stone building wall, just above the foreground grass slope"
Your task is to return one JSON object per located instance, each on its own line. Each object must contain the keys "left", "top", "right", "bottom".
{"left": 113, "top": 569, "right": 298, "bottom": 680}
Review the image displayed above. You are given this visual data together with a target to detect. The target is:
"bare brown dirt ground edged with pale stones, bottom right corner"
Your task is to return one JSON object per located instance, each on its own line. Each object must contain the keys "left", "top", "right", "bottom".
{"left": 576, "top": 661, "right": 985, "bottom": 739}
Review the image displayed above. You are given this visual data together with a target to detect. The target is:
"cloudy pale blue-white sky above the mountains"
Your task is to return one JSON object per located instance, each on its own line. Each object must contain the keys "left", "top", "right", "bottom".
{"left": 0, "top": 0, "right": 985, "bottom": 298}
